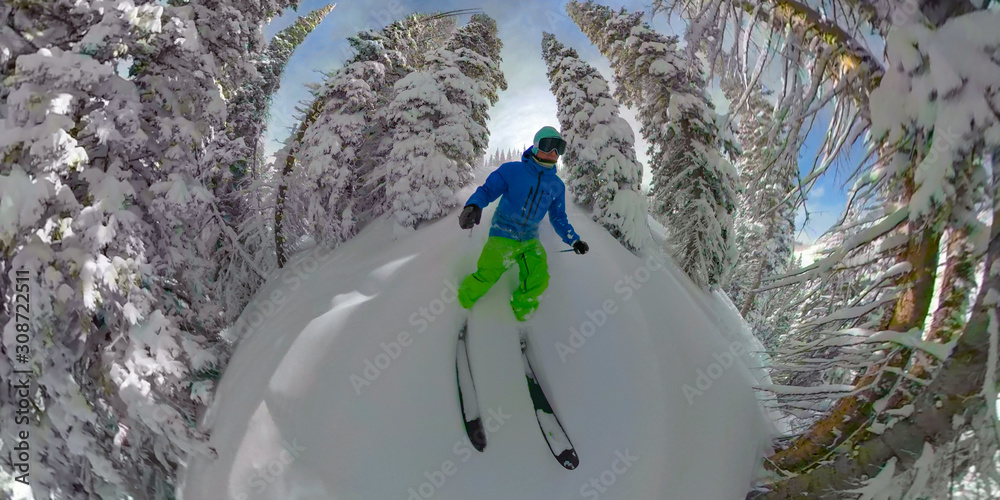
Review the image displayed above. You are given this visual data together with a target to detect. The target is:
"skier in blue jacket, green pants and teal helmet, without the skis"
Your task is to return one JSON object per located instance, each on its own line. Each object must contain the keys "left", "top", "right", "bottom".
{"left": 458, "top": 126, "right": 590, "bottom": 321}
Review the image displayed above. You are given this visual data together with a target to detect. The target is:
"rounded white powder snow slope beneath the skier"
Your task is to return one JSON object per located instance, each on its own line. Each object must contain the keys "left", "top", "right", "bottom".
{"left": 180, "top": 169, "right": 770, "bottom": 500}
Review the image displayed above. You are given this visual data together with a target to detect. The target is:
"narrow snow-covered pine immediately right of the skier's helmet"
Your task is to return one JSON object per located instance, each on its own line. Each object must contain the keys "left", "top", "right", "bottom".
{"left": 542, "top": 33, "right": 649, "bottom": 251}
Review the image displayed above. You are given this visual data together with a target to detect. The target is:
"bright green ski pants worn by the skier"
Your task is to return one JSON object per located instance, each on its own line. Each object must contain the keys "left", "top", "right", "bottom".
{"left": 458, "top": 236, "right": 549, "bottom": 321}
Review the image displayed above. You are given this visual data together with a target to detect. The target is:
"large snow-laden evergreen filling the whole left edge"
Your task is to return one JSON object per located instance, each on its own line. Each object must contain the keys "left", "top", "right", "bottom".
{"left": 0, "top": 1, "right": 296, "bottom": 498}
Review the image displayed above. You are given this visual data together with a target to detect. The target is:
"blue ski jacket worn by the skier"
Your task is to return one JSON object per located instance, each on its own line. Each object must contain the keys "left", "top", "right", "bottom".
{"left": 465, "top": 148, "right": 580, "bottom": 245}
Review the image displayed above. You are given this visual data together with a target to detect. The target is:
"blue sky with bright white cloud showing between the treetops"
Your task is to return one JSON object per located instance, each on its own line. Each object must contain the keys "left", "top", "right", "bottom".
{"left": 265, "top": 0, "right": 853, "bottom": 243}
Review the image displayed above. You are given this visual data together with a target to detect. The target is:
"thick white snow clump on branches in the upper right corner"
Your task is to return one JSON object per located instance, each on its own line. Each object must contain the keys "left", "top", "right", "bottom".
{"left": 871, "top": 12, "right": 1000, "bottom": 223}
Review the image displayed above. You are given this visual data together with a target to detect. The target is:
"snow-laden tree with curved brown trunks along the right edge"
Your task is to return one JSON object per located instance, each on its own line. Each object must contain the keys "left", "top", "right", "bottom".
{"left": 752, "top": 8, "right": 1000, "bottom": 497}
